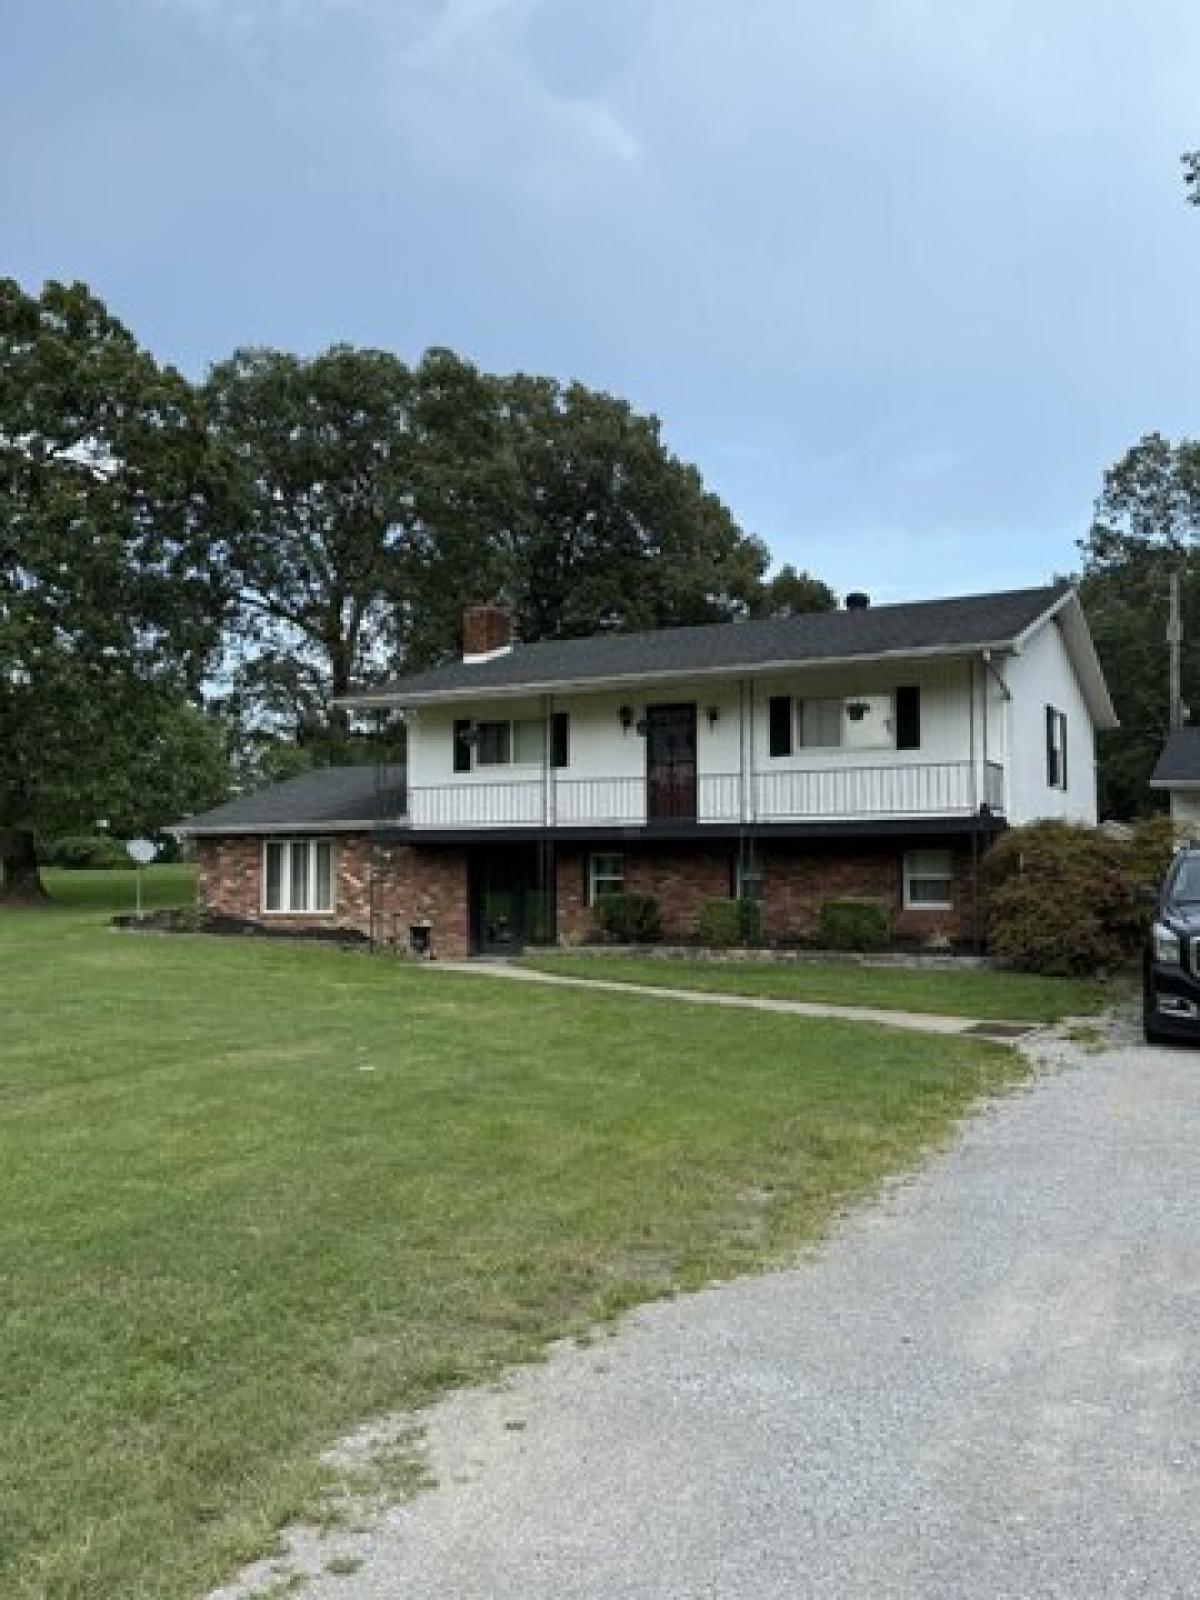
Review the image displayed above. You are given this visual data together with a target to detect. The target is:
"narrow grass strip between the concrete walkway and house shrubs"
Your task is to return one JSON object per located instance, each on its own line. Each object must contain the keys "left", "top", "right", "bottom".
{"left": 525, "top": 954, "right": 1114, "bottom": 1022}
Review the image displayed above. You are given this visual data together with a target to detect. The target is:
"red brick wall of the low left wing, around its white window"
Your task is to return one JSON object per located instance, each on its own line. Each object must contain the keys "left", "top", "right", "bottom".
{"left": 197, "top": 834, "right": 469, "bottom": 957}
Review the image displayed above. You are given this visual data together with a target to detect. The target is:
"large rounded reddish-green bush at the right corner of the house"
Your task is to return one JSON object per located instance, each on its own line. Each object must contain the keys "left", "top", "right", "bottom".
{"left": 984, "top": 822, "right": 1145, "bottom": 978}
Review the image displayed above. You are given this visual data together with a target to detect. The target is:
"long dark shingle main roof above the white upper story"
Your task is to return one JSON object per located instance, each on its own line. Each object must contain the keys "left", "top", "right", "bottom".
{"left": 354, "top": 584, "right": 1069, "bottom": 702}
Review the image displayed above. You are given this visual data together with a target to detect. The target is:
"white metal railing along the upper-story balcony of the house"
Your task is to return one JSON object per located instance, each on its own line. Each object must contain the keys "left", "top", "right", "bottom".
{"left": 408, "top": 762, "right": 1005, "bottom": 829}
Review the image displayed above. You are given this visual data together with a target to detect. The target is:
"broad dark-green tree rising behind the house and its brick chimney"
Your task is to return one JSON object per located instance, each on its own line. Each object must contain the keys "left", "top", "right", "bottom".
{"left": 205, "top": 346, "right": 832, "bottom": 760}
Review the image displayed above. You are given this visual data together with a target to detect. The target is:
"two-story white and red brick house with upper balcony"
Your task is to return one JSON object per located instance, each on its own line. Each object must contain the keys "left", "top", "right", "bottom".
{"left": 184, "top": 586, "right": 1115, "bottom": 957}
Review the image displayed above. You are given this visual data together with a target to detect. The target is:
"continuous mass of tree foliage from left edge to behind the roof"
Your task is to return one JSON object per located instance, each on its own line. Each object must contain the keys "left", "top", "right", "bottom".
{"left": 0, "top": 282, "right": 834, "bottom": 898}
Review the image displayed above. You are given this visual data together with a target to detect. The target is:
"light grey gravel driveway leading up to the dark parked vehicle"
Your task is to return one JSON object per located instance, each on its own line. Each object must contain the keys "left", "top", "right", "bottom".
{"left": 227, "top": 1024, "right": 1200, "bottom": 1600}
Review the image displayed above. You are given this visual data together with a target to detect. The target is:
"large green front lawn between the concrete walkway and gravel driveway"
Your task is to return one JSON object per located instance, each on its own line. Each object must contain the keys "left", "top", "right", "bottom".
{"left": 0, "top": 869, "right": 1021, "bottom": 1600}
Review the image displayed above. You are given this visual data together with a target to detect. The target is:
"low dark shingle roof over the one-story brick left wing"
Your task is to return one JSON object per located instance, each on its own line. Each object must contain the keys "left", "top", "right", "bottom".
{"left": 178, "top": 766, "right": 405, "bottom": 834}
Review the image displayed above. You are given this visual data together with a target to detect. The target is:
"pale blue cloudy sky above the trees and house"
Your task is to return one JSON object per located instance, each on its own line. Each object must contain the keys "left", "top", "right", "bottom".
{"left": 0, "top": 0, "right": 1200, "bottom": 600}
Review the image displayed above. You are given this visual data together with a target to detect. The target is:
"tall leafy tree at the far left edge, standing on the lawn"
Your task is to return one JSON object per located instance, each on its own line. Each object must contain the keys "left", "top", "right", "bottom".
{"left": 0, "top": 280, "right": 224, "bottom": 901}
